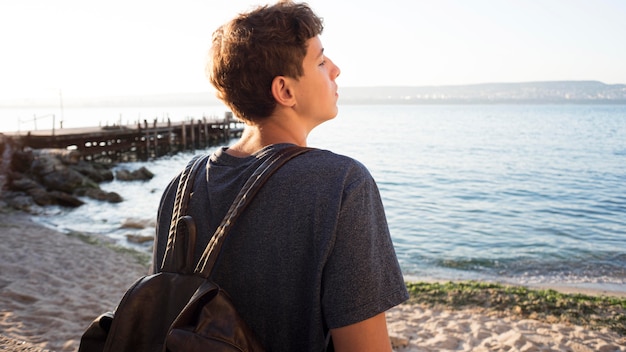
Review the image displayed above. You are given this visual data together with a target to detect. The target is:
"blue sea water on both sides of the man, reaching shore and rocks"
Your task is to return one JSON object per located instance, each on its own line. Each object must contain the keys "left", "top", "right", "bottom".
{"left": 11, "top": 105, "right": 626, "bottom": 292}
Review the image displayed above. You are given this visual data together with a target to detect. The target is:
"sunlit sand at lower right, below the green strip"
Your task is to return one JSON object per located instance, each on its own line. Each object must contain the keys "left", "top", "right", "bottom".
{"left": 387, "top": 305, "right": 626, "bottom": 352}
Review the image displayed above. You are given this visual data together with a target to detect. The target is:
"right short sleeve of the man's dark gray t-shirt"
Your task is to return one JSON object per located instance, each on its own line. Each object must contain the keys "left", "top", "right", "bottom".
{"left": 322, "top": 163, "right": 408, "bottom": 329}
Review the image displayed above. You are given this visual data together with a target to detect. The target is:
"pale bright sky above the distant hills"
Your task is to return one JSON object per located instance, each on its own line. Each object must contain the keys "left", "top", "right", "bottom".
{"left": 0, "top": 0, "right": 626, "bottom": 100}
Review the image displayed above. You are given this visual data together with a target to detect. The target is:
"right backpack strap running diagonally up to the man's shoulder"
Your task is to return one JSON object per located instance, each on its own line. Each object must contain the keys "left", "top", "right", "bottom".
{"left": 195, "top": 146, "right": 312, "bottom": 278}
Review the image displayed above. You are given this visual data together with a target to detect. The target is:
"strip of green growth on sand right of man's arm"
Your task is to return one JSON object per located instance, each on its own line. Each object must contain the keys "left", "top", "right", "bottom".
{"left": 406, "top": 281, "right": 626, "bottom": 336}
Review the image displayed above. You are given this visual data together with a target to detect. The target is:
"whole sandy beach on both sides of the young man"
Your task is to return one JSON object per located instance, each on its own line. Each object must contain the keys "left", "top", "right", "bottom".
{"left": 0, "top": 211, "right": 626, "bottom": 352}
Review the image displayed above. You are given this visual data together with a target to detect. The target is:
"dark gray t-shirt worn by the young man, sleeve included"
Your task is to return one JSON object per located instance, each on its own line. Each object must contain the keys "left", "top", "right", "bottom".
{"left": 155, "top": 144, "right": 408, "bottom": 351}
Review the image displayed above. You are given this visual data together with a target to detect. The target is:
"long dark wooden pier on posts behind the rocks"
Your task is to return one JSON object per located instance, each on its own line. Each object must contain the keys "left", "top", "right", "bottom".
{"left": 11, "top": 112, "right": 243, "bottom": 161}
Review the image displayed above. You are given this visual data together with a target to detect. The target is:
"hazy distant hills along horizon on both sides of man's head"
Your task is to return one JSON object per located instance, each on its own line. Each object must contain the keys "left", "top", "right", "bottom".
{"left": 0, "top": 81, "right": 626, "bottom": 107}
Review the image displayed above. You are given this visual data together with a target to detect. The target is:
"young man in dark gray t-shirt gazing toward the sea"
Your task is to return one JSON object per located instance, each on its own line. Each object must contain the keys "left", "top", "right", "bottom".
{"left": 154, "top": 1, "right": 408, "bottom": 352}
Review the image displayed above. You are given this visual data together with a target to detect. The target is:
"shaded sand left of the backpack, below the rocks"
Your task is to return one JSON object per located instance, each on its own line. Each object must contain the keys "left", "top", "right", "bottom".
{"left": 0, "top": 212, "right": 147, "bottom": 351}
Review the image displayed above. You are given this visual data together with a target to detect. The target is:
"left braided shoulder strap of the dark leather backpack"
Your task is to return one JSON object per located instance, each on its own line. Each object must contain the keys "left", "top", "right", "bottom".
{"left": 161, "top": 155, "right": 209, "bottom": 274}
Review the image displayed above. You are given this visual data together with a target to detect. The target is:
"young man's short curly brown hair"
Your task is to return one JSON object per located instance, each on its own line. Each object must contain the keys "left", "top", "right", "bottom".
{"left": 206, "top": 1, "right": 324, "bottom": 122}
